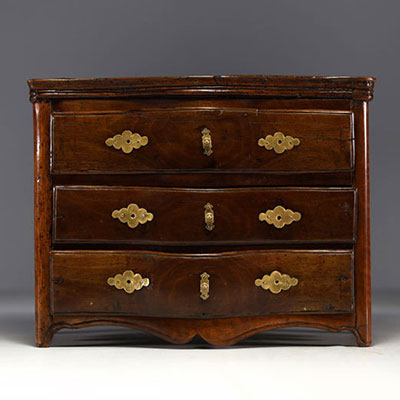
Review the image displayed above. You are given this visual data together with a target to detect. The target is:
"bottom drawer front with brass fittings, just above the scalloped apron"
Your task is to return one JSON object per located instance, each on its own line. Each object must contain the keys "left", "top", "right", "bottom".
{"left": 52, "top": 250, "right": 353, "bottom": 318}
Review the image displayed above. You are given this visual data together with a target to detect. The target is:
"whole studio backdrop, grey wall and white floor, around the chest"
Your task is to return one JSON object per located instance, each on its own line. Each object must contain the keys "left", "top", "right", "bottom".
{"left": 0, "top": 0, "right": 400, "bottom": 400}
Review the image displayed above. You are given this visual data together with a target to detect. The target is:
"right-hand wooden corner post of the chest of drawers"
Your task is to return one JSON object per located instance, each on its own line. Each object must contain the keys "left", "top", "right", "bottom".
{"left": 353, "top": 101, "right": 371, "bottom": 346}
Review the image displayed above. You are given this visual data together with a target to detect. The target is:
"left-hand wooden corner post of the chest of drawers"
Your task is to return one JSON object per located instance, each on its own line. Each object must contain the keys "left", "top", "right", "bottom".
{"left": 33, "top": 102, "right": 52, "bottom": 346}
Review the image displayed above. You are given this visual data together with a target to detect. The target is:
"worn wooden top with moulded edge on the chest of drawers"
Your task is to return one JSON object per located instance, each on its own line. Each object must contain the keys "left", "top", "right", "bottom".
{"left": 28, "top": 75, "right": 375, "bottom": 101}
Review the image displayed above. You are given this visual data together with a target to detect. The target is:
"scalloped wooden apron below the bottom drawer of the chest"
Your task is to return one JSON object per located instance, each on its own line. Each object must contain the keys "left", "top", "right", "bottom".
{"left": 49, "top": 313, "right": 365, "bottom": 346}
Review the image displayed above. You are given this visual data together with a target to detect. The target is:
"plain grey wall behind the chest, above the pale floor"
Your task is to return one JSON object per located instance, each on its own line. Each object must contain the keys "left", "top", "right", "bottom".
{"left": 0, "top": 0, "right": 400, "bottom": 295}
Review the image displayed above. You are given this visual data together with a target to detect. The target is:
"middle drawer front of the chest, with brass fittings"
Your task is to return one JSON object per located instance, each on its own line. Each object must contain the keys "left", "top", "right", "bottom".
{"left": 53, "top": 186, "right": 355, "bottom": 245}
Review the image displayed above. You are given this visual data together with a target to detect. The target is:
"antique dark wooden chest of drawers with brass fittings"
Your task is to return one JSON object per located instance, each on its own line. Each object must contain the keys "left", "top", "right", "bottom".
{"left": 29, "top": 76, "right": 375, "bottom": 346}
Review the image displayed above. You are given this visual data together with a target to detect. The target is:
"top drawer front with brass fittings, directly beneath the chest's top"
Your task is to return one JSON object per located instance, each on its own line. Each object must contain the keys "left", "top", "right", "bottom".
{"left": 52, "top": 108, "right": 353, "bottom": 173}
